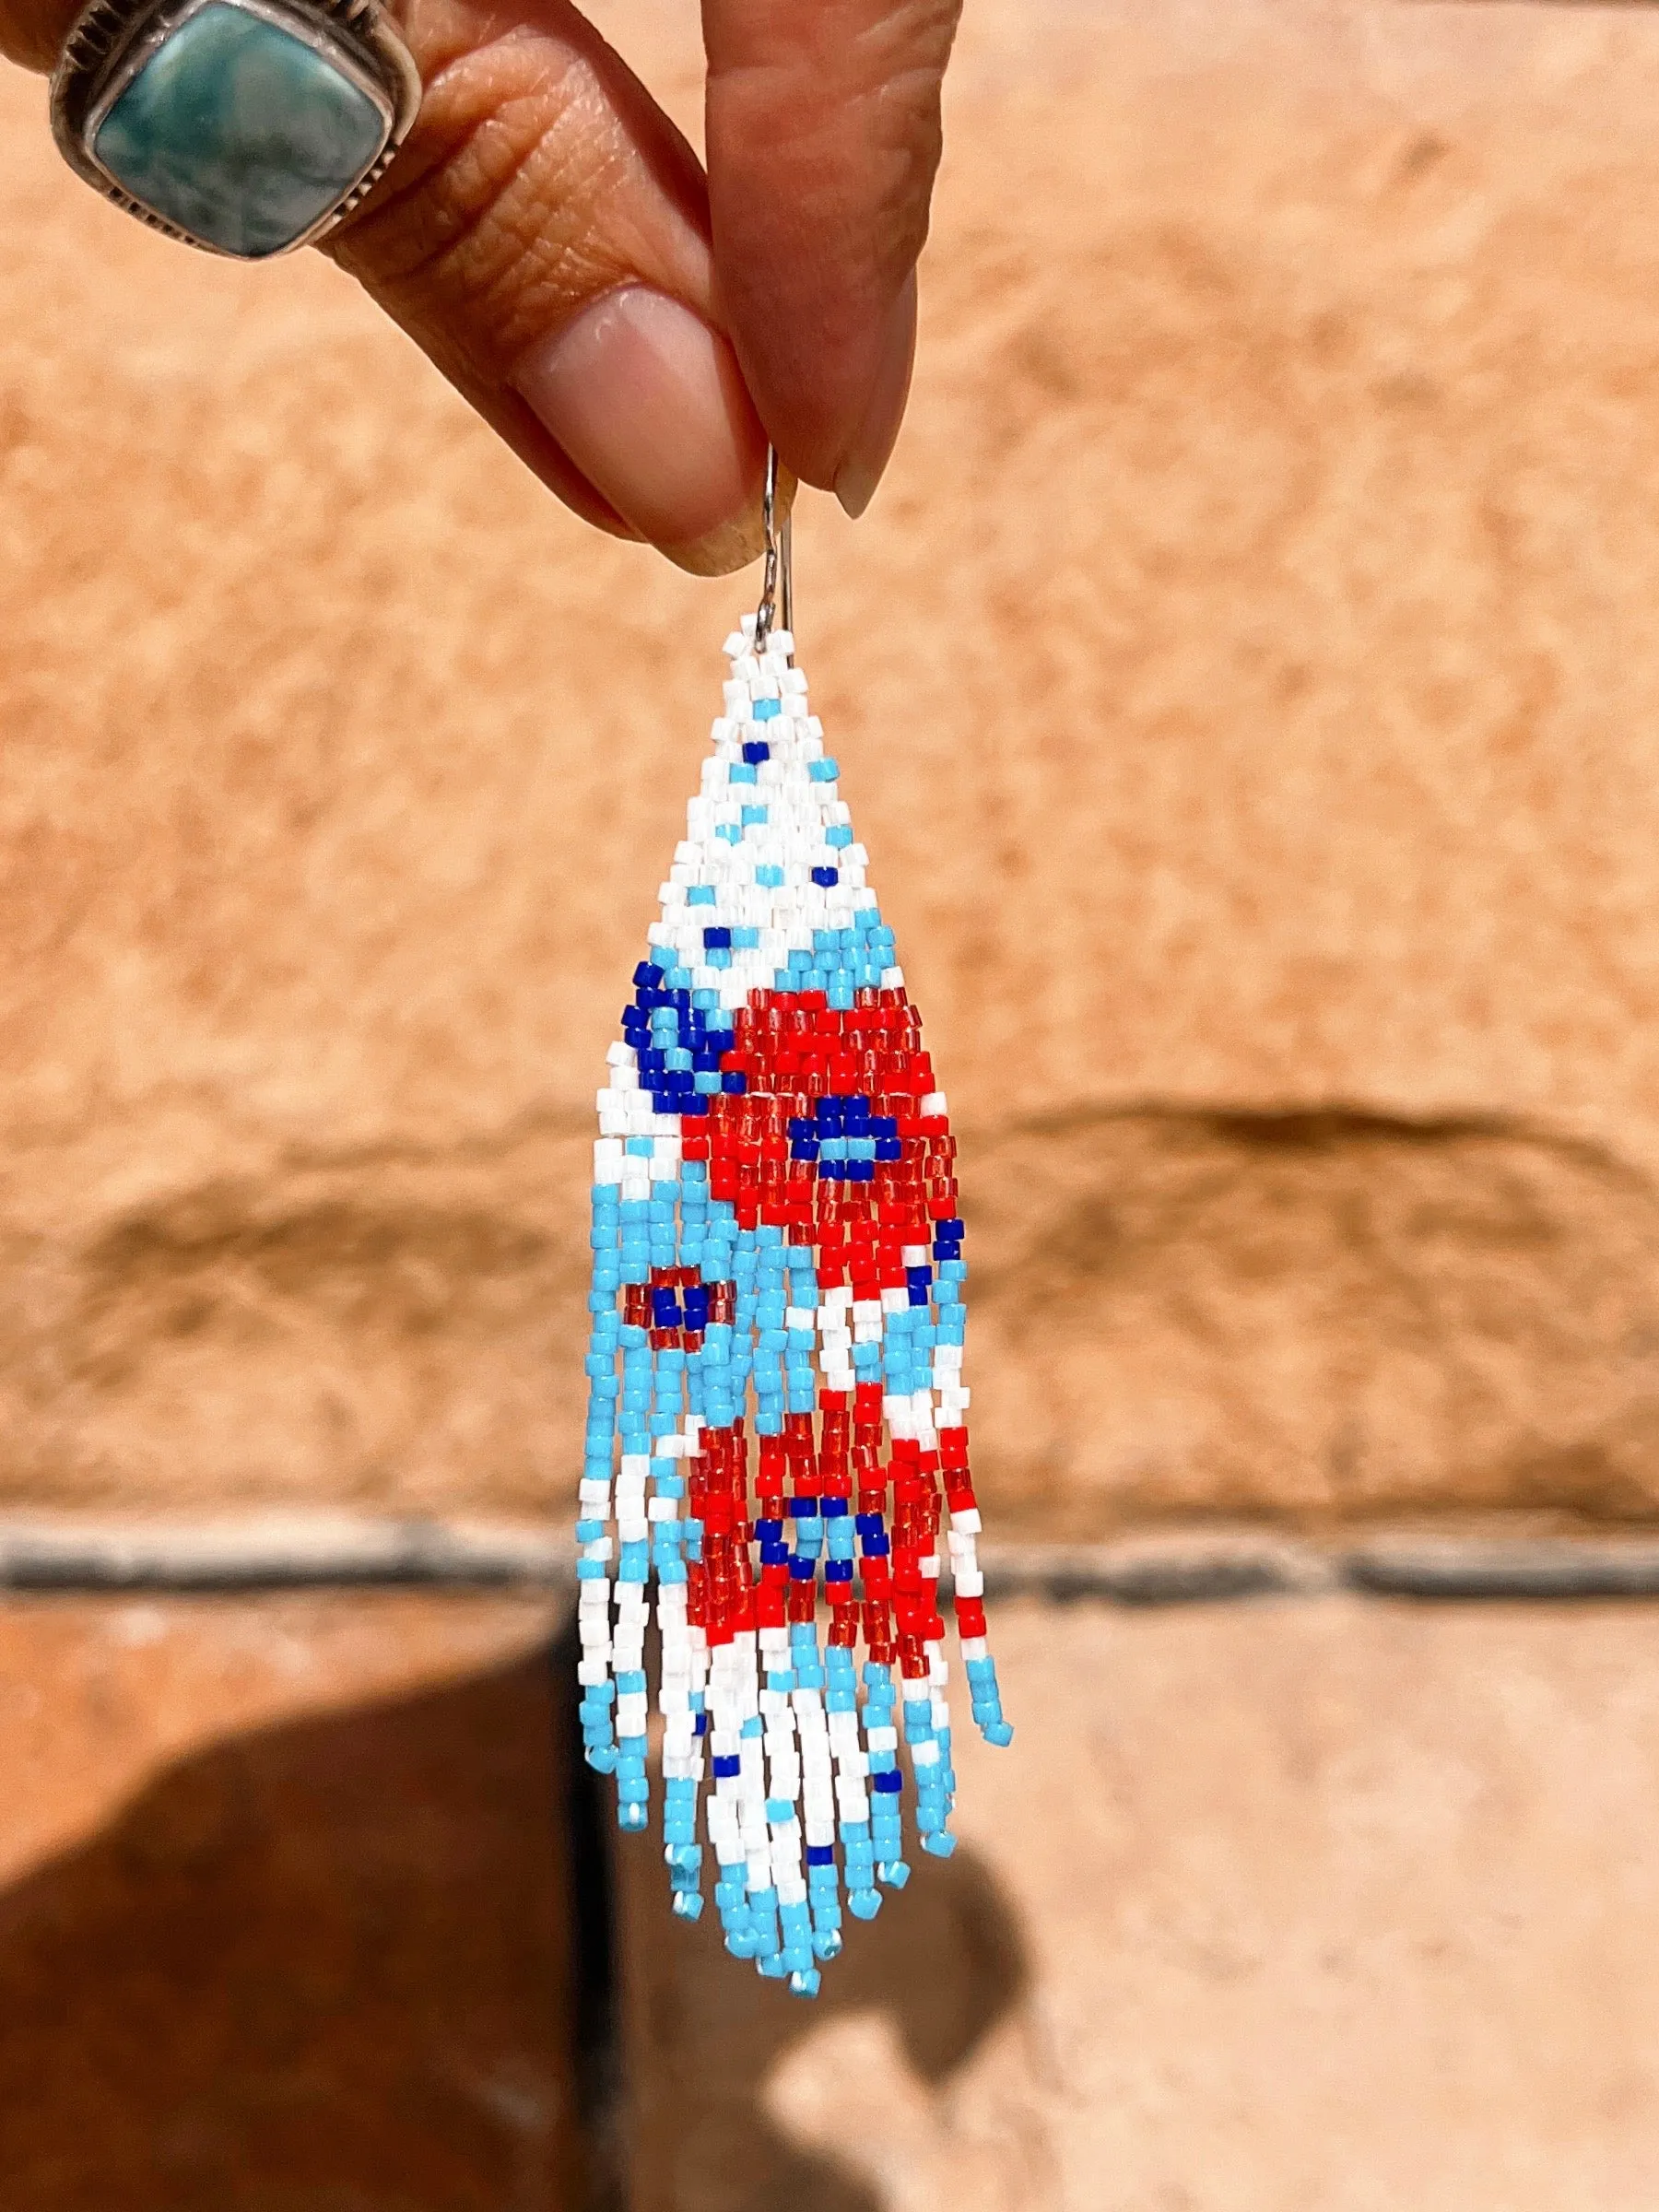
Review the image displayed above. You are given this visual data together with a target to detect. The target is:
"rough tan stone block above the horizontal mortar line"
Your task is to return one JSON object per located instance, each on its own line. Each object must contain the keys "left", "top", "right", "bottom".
{"left": 0, "top": 0, "right": 1659, "bottom": 1533}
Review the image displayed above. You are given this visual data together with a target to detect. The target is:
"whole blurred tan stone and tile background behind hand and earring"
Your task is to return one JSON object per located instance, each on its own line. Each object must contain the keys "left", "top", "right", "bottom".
{"left": 0, "top": 0, "right": 1659, "bottom": 2212}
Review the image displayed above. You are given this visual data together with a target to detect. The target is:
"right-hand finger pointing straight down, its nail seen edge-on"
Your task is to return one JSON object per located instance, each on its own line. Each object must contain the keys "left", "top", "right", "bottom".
{"left": 703, "top": 0, "right": 960, "bottom": 513}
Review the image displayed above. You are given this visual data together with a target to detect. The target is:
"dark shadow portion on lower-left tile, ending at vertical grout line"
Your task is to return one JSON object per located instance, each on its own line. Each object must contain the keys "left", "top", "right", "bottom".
{"left": 0, "top": 1654, "right": 586, "bottom": 2212}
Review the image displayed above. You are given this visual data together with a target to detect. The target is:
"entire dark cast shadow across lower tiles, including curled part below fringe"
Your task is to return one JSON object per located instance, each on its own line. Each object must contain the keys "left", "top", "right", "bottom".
{"left": 0, "top": 1635, "right": 1040, "bottom": 2212}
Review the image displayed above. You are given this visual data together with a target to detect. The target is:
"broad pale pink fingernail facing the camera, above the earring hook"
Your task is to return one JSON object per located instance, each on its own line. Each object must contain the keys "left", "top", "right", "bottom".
{"left": 513, "top": 286, "right": 765, "bottom": 575}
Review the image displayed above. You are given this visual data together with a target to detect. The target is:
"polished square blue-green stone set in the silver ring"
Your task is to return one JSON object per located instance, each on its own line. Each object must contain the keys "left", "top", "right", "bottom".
{"left": 93, "top": 0, "right": 387, "bottom": 261}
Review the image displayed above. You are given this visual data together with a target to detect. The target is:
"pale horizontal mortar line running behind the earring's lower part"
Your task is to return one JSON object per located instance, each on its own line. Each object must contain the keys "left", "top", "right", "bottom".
{"left": 0, "top": 1511, "right": 1659, "bottom": 1606}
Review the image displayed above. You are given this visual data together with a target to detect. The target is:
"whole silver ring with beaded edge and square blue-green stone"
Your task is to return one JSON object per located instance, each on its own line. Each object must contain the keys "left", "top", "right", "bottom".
{"left": 51, "top": 0, "right": 420, "bottom": 261}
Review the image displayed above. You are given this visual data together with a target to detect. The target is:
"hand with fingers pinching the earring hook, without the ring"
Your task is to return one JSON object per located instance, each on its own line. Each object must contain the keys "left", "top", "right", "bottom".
{"left": 0, "top": 0, "right": 960, "bottom": 575}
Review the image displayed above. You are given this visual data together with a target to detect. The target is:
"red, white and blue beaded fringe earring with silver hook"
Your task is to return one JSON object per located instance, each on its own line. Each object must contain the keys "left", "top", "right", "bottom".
{"left": 575, "top": 458, "right": 1013, "bottom": 1997}
